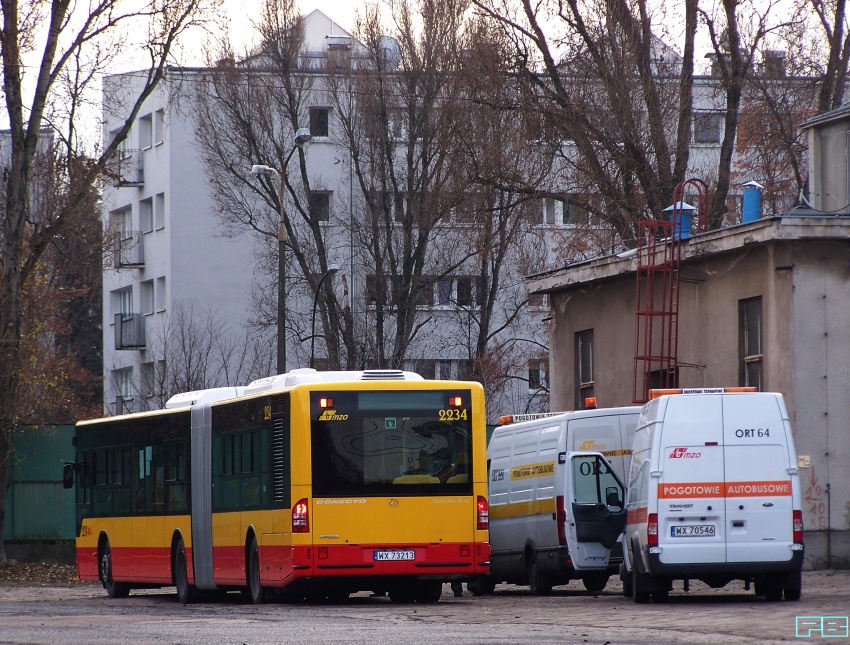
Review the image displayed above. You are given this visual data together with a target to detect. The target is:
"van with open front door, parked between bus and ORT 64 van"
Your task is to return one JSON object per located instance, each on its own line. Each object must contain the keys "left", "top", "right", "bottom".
{"left": 478, "top": 406, "right": 640, "bottom": 594}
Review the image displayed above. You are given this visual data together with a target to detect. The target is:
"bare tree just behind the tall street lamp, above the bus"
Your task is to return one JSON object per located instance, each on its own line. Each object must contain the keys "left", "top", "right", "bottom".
{"left": 187, "top": 0, "right": 355, "bottom": 367}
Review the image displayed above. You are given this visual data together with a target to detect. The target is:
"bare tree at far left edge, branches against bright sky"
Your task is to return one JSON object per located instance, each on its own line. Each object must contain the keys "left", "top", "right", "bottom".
{"left": 0, "top": 0, "right": 210, "bottom": 565}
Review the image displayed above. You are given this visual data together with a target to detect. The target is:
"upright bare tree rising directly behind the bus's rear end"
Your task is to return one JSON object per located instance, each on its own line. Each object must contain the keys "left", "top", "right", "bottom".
{"left": 329, "top": 1, "right": 478, "bottom": 368}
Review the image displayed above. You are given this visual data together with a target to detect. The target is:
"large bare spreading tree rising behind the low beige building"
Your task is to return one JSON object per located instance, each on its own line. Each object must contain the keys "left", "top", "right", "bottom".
{"left": 473, "top": 0, "right": 800, "bottom": 236}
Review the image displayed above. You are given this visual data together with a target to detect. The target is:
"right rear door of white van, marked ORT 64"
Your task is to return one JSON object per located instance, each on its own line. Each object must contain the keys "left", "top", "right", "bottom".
{"left": 723, "top": 394, "right": 794, "bottom": 562}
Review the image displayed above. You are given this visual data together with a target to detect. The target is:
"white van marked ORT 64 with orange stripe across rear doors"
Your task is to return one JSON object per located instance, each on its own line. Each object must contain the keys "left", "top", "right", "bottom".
{"left": 620, "top": 388, "right": 803, "bottom": 602}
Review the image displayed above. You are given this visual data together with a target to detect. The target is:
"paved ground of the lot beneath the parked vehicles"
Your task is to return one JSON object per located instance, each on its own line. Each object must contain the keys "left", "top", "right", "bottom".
{"left": 0, "top": 571, "right": 850, "bottom": 645}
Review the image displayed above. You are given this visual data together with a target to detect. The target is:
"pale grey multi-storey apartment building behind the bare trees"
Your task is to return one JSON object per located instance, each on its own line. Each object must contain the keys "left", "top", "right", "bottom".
{"left": 103, "top": 10, "right": 788, "bottom": 420}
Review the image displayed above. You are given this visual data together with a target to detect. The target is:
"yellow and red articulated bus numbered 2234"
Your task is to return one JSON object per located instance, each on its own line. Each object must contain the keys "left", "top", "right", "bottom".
{"left": 65, "top": 369, "right": 490, "bottom": 603}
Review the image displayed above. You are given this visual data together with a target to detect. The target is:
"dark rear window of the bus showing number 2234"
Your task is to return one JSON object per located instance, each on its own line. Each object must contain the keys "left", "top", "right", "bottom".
{"left": 310, "top": 390, "right": 472, "bottom": 497}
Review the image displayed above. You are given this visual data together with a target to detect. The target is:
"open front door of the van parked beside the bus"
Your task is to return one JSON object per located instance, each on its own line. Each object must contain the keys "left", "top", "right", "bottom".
{"left": 566, "top": 452, "right": 626, "bottom": 571}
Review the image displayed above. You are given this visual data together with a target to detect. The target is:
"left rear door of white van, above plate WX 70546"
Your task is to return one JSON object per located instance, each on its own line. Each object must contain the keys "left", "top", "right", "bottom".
{"left": 658, "top": 394, "right": 726, "bottom": 564}
